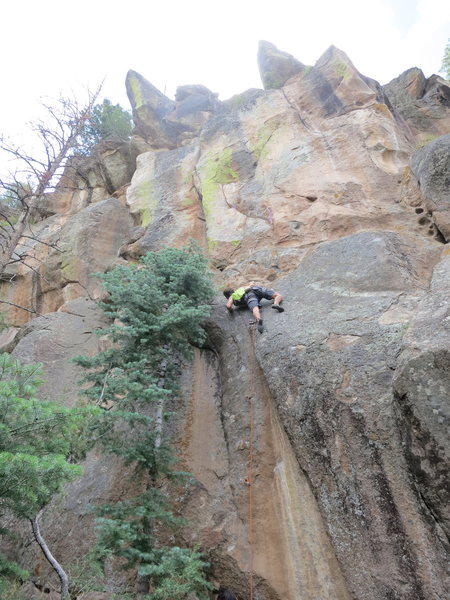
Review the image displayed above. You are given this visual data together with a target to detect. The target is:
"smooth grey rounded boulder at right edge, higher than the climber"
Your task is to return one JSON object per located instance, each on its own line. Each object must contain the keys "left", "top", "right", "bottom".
{"left": 411, "top": 134, "right": 450, "bottom": 242}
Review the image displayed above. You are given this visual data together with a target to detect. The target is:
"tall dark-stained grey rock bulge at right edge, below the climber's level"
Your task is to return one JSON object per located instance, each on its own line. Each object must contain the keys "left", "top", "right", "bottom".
{"left": 394, "top": 251, "right": 450, "bottom": 537}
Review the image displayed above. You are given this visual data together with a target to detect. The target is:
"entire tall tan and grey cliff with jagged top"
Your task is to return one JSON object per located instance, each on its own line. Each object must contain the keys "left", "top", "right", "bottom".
{"left": 1, "top": 42, "right": 450, "bottom": 600}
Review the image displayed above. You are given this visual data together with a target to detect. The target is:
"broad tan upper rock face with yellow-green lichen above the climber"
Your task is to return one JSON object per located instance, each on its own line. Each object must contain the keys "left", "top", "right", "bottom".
{"left": 189, "top": 49, "right": 419, "bottom": 278}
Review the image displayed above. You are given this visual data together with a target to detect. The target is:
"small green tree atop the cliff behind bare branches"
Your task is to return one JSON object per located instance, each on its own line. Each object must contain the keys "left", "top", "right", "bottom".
{"left": 80, "top": 98, "right": 133, "bottom": 154}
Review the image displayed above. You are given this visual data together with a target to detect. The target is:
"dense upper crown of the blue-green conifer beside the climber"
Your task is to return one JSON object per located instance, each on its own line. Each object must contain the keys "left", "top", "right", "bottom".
{"left": 75, "top": 245, "right": 214, "bottom": 419}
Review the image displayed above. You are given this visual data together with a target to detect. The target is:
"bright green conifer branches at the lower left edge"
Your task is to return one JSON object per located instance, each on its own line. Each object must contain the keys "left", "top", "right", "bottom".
{"left": 0, "top": 354, "right": 98, "bottom": 518}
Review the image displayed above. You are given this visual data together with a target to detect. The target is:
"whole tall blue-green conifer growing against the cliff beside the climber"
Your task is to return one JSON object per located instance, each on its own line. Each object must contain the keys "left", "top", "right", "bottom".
{"left": 75, "top": 244, "right": 214, "bottom": 600}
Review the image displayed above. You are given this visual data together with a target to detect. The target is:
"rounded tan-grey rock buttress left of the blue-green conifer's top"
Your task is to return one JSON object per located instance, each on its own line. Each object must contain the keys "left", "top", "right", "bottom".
{"left": 0, "top": 198, "right": 131, "bottom": 325}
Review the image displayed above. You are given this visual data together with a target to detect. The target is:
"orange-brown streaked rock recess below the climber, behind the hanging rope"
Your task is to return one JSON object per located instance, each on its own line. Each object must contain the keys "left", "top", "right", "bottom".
{"left": 172, "top": 346, "right": 350, "bottom": 600}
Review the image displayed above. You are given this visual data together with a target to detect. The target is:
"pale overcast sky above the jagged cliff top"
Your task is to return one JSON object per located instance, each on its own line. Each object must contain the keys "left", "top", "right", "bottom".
{"left": 0, "top": 0, "right": 450, "bottom": 170}
